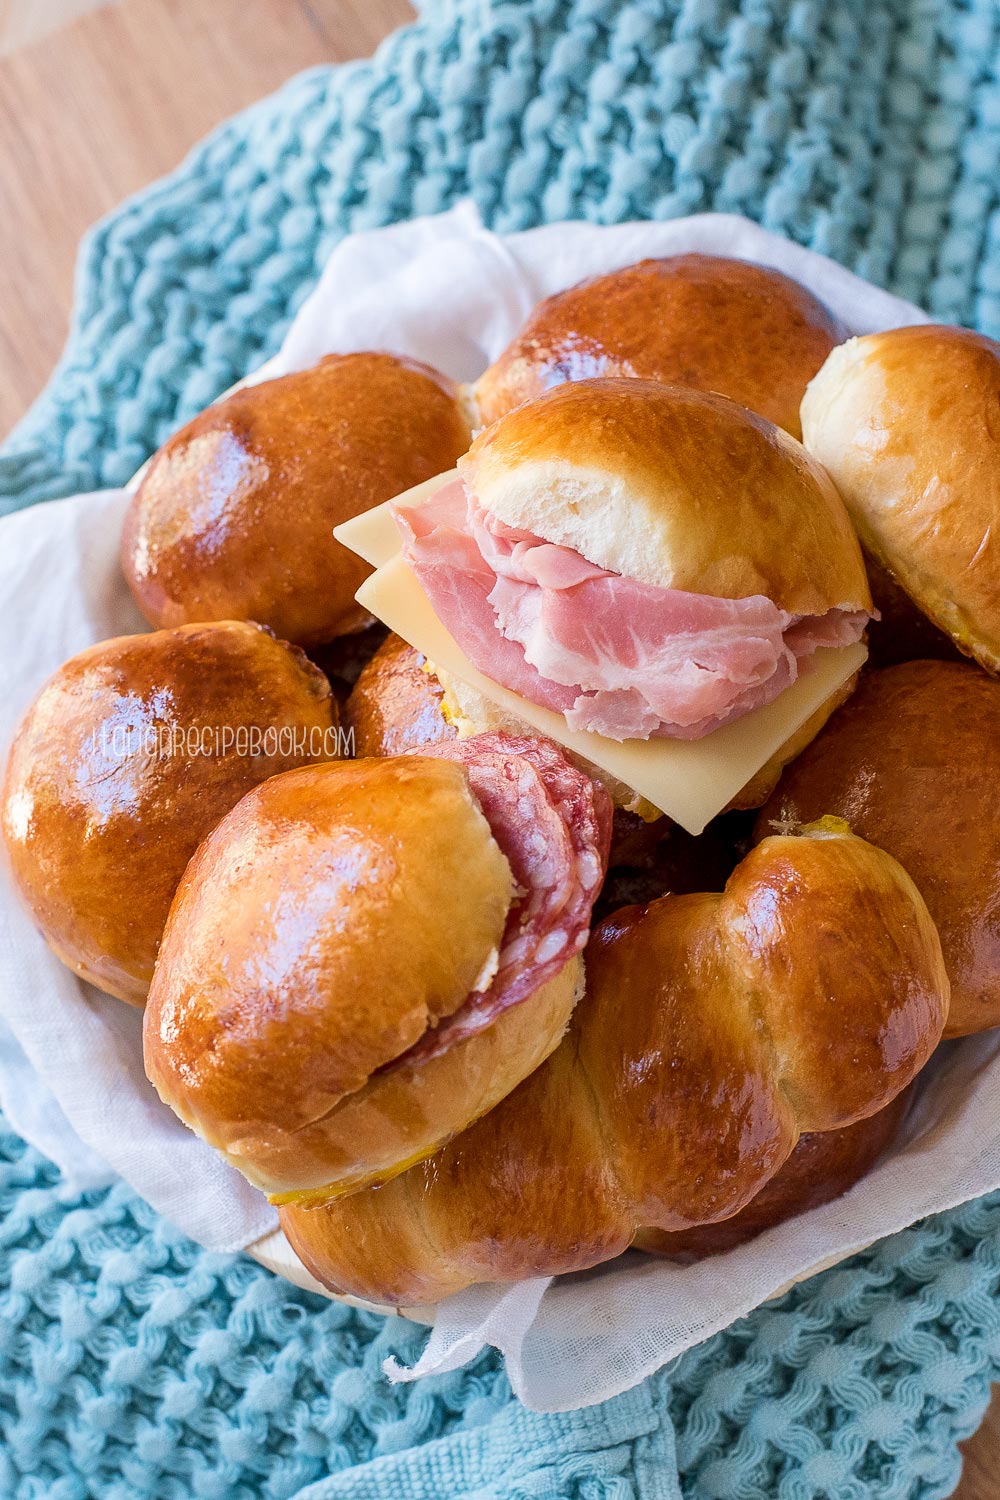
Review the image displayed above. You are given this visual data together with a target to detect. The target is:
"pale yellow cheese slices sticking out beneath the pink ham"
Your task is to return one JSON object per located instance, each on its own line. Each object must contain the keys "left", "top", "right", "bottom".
{"left": 353, "top": 552, "right": 868, "bottom": 834}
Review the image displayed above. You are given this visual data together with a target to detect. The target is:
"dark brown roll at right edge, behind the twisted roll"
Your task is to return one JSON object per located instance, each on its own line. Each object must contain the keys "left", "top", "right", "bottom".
{"left": 757, "top": 662, "right": 1000, "bottom": 1037}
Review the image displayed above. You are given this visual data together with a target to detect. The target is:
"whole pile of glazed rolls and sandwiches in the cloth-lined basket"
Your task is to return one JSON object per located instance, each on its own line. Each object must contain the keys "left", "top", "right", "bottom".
{"left": 0, "top": 246, "right": 1000, "bottom": 1304}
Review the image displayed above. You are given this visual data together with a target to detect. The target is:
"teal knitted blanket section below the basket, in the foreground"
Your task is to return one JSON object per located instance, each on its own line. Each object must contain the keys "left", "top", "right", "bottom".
{"left": 0, "top": 1124, "right": 1000, "bottom": 1500}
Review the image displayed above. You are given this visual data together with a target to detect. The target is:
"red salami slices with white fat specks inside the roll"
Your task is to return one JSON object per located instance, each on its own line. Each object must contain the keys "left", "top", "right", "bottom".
{"left": 388, "top": 731, "right": 612, "bottom": 1068}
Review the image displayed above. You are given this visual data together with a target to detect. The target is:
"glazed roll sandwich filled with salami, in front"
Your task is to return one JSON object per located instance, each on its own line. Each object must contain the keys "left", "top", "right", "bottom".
{"left": 144, "top": 737, "right": 610, "bottom": 1202}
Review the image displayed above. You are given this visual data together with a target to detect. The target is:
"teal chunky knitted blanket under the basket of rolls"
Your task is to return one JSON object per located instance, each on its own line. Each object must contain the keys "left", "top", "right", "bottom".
{"left": 0, "top": 0, "right": 1000, "bottom": 1500}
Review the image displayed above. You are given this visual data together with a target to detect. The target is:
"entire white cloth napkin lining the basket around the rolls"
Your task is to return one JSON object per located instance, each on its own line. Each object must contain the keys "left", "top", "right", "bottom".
{"left": 0, "top": 204, "right": 1000, "bottom": 1410}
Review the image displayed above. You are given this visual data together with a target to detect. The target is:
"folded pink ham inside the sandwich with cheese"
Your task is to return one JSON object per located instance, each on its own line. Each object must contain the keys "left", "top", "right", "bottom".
{"left": 394, "top": 480, "right": 868, "bottom": 740}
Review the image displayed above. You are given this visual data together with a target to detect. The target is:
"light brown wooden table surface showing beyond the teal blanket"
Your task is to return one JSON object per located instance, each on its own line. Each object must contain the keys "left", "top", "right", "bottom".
{"left": 0, "top": 0, "right": 1000, "bottom": 1500}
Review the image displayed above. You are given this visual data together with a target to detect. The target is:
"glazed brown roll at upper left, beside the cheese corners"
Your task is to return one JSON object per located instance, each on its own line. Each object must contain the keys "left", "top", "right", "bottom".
{"left": 121, "top": 354, "right": 469, "bottom": 645}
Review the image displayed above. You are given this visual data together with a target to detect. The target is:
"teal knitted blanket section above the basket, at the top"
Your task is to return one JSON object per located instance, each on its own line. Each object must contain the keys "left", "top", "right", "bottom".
{"left": 0, "top": 0, "right": 1000, "bottom": 506}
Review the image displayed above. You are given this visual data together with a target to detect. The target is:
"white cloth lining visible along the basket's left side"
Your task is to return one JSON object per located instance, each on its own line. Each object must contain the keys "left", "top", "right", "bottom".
{"left": 0, "top": 491, "right": 277, "bottom": 1250}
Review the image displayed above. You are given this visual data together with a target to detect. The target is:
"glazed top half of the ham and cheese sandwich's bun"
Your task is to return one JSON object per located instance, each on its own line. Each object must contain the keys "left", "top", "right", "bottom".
{"left": 470, "top": 380, "right": 871, "bottom": 615}
